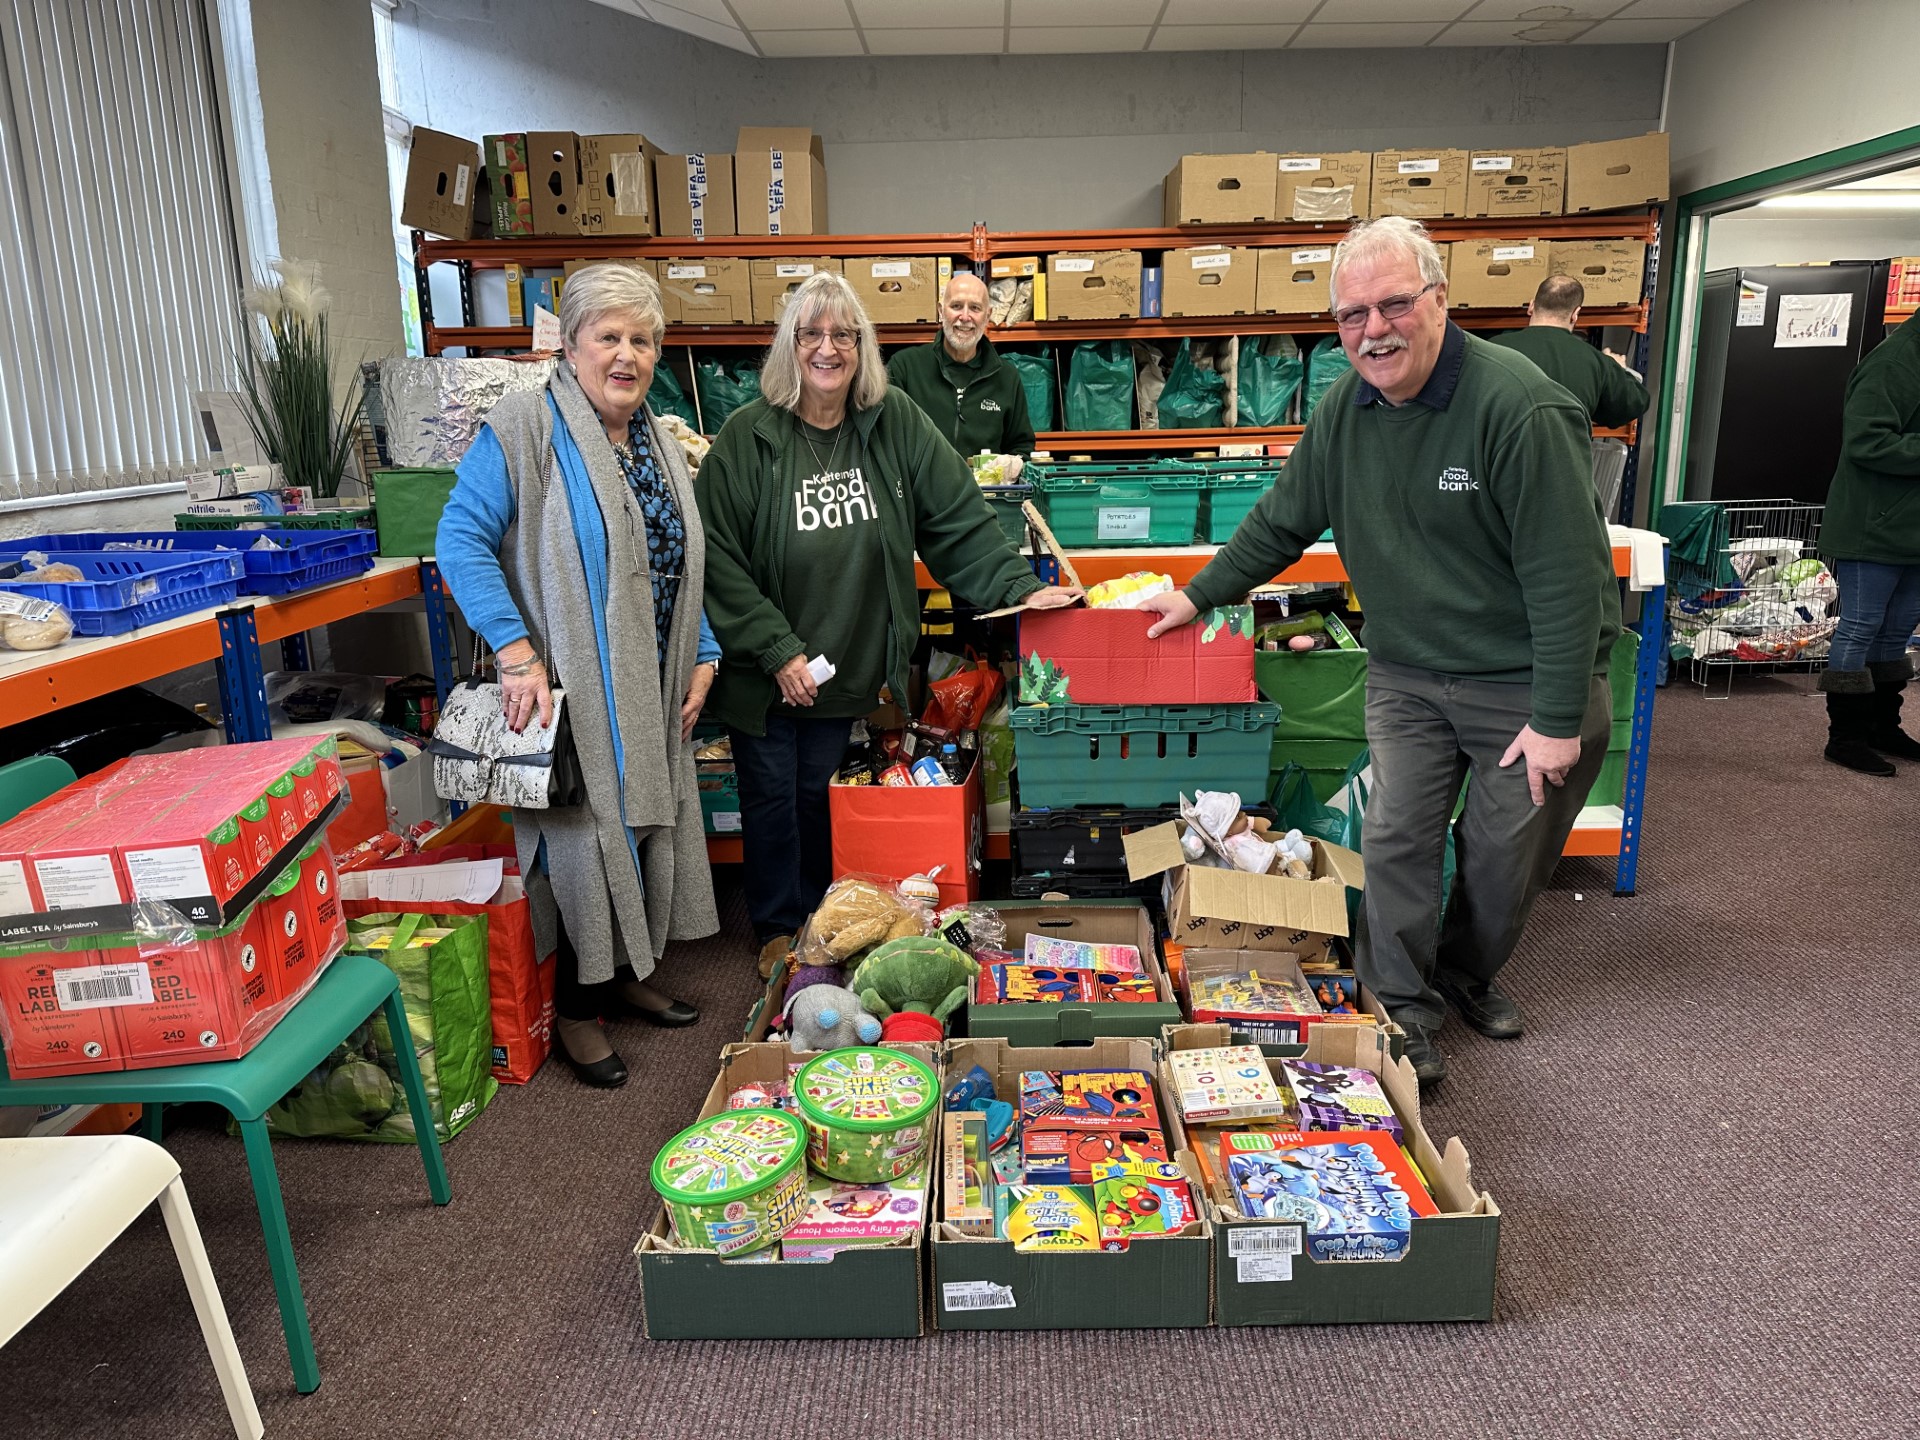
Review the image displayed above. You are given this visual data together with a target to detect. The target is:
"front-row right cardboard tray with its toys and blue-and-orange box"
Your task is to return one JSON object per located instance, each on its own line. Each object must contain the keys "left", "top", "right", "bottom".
{"left": 1162, "top": 1025, "right": 1500, "bottom": 1325}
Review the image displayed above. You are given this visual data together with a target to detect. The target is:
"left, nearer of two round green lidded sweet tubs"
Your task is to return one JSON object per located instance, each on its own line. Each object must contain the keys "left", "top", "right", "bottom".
{"left": 653, "top": 1110, "right": 806, "bottom": 1256}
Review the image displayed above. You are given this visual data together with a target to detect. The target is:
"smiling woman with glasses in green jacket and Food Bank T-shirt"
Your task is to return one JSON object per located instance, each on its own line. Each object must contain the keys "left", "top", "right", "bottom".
{"left": 693, "top": 275, "right": 1079, "bottom": 975}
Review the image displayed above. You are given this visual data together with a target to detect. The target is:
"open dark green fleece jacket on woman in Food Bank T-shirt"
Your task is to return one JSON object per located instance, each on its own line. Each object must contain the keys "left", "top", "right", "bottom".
{"left": 693, "top": 392, "right": 1043, "bottom": 735}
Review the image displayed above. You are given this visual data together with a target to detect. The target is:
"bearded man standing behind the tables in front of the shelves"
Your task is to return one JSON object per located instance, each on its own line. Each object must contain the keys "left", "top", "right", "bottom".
{"left": 887, "top": 275, "right": 1033, "bottom": 455}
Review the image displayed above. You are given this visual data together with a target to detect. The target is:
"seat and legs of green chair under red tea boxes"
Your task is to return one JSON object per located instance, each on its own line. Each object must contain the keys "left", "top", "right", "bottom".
{"left": 0, "top": 954, "right": 453, "bottom": 1394}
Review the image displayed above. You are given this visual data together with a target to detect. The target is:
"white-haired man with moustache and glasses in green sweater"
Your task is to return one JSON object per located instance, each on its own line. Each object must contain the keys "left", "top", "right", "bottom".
{"left": 1146, "top": 217, "right": 1620, "bottom": 1083}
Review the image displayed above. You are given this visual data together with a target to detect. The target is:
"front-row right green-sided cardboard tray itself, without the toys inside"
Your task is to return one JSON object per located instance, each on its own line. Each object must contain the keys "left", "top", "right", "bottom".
{"left": 1162, "top": 1025, "right": 1500, "bottom": 1325}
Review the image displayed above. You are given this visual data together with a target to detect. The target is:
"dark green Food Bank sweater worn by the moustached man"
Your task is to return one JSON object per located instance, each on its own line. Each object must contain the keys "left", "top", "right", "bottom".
{"left": 1182, "top": 324, "right": 1620, "bottom": 737}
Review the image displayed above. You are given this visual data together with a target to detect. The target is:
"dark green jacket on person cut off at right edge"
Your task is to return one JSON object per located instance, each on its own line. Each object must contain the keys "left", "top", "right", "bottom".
{"left": 1820, "top": 321, "right": 1920, "bottom": 564}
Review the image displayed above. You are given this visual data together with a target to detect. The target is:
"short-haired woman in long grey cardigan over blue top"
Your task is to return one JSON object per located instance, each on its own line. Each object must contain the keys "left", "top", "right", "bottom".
{"left": 438, "top": 265, "right": 720, "bottom": 1089}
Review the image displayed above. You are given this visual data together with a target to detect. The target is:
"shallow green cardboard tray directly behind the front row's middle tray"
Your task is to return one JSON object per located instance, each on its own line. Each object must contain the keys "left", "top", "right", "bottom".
{"left": 966, "top": 900, "right": 1181, "bottom": 1046}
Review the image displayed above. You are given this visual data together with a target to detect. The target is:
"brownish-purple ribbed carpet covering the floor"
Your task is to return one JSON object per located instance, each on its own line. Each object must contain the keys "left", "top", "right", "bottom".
{"left": 0, "top": 676, "right": 1920, "bottom": 1440}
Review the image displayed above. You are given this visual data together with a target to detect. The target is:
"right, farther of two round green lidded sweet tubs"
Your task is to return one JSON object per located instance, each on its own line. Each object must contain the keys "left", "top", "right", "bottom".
{"left": 793, "top": 1046, "right": 941, "bottom": 1183}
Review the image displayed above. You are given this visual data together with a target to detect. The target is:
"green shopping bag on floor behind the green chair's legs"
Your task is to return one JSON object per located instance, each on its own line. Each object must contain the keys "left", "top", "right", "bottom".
{"left": 267, "top": 914, "right": 499, "bottom": 1144}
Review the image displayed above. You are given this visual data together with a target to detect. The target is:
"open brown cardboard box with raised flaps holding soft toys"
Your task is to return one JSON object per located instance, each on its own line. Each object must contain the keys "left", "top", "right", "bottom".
{"left": 1125, "top": 816, "right": 1367, "bottom": 960}
